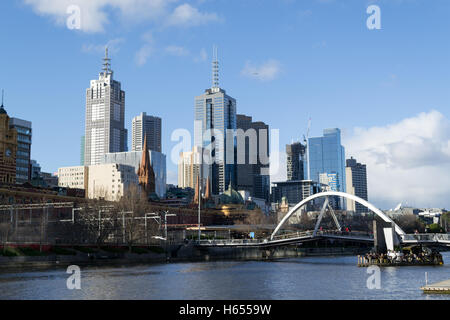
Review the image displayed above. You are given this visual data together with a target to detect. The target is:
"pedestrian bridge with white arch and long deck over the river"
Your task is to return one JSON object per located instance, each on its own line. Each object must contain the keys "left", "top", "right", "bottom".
{"left": 196, "top": 191, "right": 450, "bottom": 247}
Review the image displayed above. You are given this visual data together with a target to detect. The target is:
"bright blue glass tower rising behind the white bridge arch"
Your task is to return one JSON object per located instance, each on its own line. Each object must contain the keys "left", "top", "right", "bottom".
{"left": 307, "top": 128, "right": 346, "bottom": 209}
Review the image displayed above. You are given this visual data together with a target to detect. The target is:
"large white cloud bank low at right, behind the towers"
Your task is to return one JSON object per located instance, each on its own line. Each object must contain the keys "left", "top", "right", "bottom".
{"left": 344, "top": 111, "right": 450, "bottom": 209}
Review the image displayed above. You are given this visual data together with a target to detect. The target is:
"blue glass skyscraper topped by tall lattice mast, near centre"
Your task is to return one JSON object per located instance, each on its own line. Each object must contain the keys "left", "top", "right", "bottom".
{"left": 194, "top": 48, "right": 236, "bottom": 194}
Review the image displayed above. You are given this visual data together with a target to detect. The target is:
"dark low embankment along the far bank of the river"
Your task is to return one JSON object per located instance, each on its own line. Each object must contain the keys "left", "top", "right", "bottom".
{"left": 0, "top": 244, "right": 366, "bottom": 270}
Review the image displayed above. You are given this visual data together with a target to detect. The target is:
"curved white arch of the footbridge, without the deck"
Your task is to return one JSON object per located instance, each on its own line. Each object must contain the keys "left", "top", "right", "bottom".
{"left": 270, "top": 191, "right": 405, "bottom": 240}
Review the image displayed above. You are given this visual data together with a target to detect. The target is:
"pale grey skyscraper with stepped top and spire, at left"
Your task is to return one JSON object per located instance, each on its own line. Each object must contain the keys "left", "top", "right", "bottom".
{"left": 84, "top": 48, "right": 127, "bottom": 166}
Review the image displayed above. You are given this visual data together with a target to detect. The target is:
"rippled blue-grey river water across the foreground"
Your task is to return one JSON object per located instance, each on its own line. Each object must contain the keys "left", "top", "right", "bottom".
{"left": 0, "top": 252, "right": 450, "bottom": 300}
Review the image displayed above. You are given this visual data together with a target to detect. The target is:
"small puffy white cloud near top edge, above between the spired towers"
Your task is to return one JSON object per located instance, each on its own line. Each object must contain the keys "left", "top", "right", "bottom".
{"left": 166, "top": 3, "right": 221, "bottom": 26}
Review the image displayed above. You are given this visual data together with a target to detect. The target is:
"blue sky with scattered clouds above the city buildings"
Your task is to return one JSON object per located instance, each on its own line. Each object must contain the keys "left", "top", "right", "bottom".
{"left": 0, "top": 0, "right": 450, "bottom": 208}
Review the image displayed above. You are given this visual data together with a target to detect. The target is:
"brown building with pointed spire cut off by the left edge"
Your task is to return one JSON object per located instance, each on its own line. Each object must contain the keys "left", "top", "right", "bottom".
{"left": 0, "top": 97, "right": 17, "bottom": 184}
